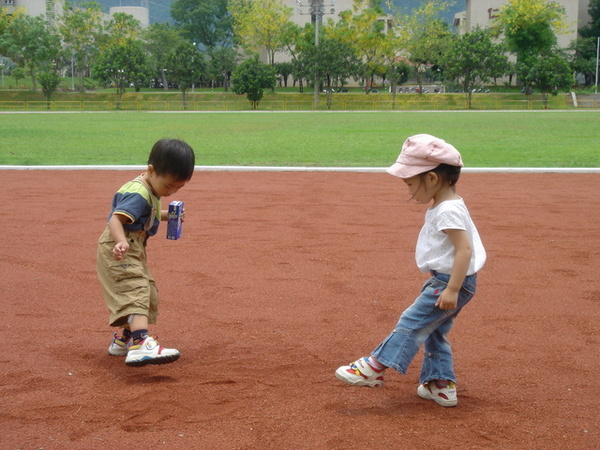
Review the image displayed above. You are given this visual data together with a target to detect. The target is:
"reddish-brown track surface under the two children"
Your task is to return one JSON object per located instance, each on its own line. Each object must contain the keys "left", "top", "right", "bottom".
{"left": 0, "top": 170, "right": 600, "bottom": 449}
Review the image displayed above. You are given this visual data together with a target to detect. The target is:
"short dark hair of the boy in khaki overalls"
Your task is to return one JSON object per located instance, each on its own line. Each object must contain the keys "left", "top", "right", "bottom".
{"left": 148, "top": 139, "right": 196, "bottom": 181}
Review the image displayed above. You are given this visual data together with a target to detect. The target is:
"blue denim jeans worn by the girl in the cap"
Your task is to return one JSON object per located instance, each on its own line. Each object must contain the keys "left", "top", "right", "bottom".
{"left": 371, "top": 272, "right": 477, "bottom": 383}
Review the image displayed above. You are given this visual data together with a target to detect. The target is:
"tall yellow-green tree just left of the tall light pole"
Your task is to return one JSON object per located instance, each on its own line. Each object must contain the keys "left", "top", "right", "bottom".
{"left": 229, "top": 0, "right": 292, "bottom": 65}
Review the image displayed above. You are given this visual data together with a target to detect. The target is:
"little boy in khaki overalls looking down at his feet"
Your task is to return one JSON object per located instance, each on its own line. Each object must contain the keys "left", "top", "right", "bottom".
{"left": 97, "top": 139, "right": 195, "bottom": 367}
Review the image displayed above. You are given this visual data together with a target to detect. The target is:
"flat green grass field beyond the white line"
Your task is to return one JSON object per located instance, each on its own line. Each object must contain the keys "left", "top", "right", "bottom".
{"left": 0, "top": 111, "right": 600, "bottom": 168}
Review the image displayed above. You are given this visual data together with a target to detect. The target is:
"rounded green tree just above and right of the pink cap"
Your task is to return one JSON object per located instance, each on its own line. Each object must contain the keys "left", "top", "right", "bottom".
{"left": 443, "top": 28, "right": 508, "bottom": 108}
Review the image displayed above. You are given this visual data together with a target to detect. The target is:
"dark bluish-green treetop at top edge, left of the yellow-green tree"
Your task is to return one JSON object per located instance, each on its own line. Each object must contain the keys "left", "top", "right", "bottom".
{"left": 171, "top": 0, "right": 233, "bottom": 49}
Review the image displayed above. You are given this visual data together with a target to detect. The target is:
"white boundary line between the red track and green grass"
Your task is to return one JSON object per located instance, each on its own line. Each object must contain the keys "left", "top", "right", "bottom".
{"left": 0, "top": 165, "right": 600, "bottom": 173}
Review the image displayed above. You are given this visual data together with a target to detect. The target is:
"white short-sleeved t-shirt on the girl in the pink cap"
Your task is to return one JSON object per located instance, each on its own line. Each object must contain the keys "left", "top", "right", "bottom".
{"left": 415, "top": 198, "right": 486, "bottom": 275}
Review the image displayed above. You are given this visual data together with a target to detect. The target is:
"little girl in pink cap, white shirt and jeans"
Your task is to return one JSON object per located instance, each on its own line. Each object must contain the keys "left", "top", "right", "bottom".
{"left": 335, "top": 134, "right": 486, "bottom": 407}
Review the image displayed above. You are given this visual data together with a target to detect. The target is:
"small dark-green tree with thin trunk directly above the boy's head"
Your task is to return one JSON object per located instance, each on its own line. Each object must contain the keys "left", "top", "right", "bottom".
{"left": 167, "top": 42, "right": 207, "bottom": 109}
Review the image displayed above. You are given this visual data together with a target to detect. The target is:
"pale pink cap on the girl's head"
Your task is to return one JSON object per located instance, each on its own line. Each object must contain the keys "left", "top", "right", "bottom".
{"left": 386, "top": 134, "right": 463, "bottom": 178}
